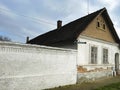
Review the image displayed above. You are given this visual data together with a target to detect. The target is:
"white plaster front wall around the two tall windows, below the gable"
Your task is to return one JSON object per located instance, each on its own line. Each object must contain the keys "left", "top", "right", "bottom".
{"left": 77, "top": 36, "right": 120, "bottom": 69}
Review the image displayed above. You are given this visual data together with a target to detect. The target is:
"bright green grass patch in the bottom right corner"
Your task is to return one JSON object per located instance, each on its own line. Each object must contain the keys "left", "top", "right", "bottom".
{"left": 94, "top": 82, "right": 120, "bottom": 90}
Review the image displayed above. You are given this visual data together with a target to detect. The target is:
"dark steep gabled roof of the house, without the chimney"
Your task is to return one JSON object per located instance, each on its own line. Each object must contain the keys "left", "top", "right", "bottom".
{"left": 28, "top": 8, "right": 119, "bottom": 45}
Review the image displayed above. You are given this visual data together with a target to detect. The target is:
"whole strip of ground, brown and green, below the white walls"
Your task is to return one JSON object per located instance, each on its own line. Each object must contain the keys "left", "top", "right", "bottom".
{"left": 47, "top": 76, "right": 120, "bottom": 90}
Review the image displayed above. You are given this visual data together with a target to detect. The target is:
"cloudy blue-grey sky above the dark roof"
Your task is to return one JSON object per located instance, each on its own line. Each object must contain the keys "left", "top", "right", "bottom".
{"left": 0, "top": 0, "right": 120, "bottom": 43}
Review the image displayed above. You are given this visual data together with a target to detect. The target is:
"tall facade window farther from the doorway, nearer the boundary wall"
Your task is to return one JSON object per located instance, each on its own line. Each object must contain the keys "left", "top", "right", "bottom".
{"left": 91, "top": 46, "right": 97, "bottom": 64}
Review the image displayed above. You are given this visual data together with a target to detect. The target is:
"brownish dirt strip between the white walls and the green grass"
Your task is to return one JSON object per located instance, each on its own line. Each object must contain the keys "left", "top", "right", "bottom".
{"left": 48, "top": 76, "right": 120, "bottom": 90}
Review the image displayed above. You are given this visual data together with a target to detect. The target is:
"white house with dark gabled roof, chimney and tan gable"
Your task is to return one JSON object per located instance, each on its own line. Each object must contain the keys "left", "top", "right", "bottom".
{"left": 27, "top": 8, "right": 120, "bottom": 75}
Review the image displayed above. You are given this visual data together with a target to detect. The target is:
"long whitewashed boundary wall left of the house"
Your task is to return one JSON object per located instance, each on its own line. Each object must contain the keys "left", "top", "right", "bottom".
{"left": 0, "top": 42, "right": 77, "bottom": 90}
